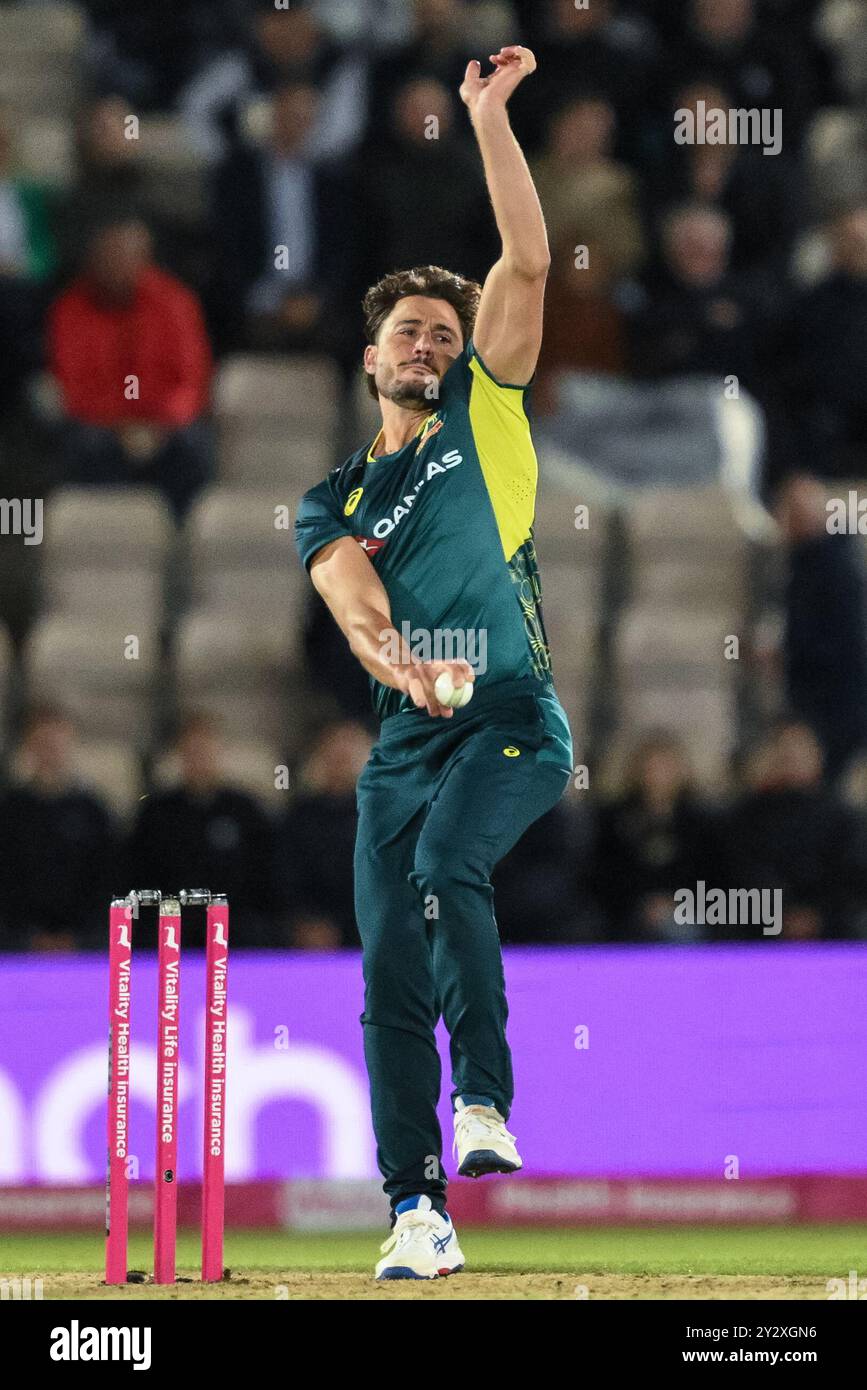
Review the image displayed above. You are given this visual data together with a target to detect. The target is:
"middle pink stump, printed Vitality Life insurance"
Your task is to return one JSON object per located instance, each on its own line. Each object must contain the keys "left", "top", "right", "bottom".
{"left": 154, "top": 898, "right": 181, "bottom": 1284}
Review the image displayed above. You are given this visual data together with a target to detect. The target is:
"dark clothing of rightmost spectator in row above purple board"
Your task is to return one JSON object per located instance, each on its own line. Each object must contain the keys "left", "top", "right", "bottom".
{"left": 711, "top": 788, "right": 867, "bottom": 940}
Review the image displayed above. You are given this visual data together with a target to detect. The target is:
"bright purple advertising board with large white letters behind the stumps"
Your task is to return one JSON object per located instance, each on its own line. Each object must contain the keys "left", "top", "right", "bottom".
{"left": 0, "top": 942, "right": 867, "bottom": 1186}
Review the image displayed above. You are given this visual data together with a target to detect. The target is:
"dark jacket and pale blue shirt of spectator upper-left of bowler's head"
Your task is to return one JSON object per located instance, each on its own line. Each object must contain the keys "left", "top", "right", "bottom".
{"left": 210, "top": 146, "right": 354, "bottom": 354}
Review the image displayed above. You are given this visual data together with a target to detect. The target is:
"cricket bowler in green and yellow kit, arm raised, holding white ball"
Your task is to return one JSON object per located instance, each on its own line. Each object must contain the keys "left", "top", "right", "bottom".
{"left": 296, "top": 46, "right": 572, "bottom": 1279}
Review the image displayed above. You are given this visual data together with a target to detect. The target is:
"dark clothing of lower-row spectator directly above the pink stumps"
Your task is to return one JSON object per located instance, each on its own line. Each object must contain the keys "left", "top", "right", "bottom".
{"left": 126, "top": 787, "right": 274, "bottom": 945}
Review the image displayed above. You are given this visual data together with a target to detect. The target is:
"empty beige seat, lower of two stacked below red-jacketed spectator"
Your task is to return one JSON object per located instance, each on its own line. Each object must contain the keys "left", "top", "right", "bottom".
{"left": 24, "top": 614, "right": 158, "bottom": 749}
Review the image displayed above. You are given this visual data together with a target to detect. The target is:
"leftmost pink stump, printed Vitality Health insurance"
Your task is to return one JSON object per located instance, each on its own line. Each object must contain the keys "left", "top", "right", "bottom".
{"left": 106, "top": 898, "right": 132, "bottom": 1284}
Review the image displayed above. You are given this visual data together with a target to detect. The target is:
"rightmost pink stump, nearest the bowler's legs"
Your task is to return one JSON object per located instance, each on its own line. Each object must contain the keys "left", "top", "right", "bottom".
{"left": 201, "top": 897, "right": 229, "bottom": 1283}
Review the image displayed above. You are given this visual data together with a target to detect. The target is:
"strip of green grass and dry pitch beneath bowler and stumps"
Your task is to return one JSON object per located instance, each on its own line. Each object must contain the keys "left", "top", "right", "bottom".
{"left": 0, "top": 1226, "right": 867, "bottom": 1301}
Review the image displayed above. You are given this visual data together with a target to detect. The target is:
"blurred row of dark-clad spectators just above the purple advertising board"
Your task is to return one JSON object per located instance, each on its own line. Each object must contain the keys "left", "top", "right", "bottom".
{"left": 0, "top": 706, "right": 867, "bottom": 951}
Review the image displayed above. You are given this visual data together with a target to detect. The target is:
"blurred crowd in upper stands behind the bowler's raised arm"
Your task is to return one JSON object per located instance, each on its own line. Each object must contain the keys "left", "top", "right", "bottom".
{"left": 0, "top": 0, "right": 867, "bottom": 500}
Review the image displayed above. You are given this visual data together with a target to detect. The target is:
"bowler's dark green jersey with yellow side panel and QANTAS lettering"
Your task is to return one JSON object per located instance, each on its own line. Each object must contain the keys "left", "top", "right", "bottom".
{"left": 295, "top": 339, "right": 568, "bottom": 761}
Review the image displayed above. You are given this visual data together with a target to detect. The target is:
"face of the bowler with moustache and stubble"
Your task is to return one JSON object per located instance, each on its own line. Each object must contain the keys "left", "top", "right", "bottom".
{"left": 365, "top": 295, "right": 464, "bottom": 410}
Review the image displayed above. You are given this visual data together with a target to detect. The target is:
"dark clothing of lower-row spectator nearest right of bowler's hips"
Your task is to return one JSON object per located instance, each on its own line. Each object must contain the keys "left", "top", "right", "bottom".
{"left": 591, "top": 794, "right": 718, "bottom": 941}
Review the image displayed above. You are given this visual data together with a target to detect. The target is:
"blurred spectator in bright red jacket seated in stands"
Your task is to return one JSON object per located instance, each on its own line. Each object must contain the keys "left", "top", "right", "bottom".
{"left": 49, "top": 217, "right": 213, "bottom": 517}
